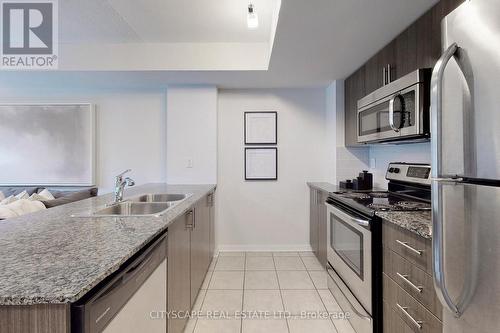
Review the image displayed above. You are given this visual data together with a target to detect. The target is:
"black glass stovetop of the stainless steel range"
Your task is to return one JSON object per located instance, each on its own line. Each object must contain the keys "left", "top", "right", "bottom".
{"left": 330, "top": 191, "right": 431, "bottom": 215}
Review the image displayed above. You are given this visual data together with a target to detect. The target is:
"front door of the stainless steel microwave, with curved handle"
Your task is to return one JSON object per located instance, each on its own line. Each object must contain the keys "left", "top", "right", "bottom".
{"left": 358, "top": 85, "right": 420, "bottom": 142}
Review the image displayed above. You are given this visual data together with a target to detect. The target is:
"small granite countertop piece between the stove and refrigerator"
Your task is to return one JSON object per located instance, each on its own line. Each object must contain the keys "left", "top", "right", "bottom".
{"left": 375, "top": 211, "right": 432, "bottom": 239}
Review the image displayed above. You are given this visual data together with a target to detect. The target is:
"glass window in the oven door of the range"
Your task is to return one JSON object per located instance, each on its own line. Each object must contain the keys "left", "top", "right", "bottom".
{"left": 330, "top": 214, "right": 365, "bottom": 280}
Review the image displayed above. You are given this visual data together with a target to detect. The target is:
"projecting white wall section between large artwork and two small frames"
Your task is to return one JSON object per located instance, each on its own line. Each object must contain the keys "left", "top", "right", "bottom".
{"left": 167, "top": 86, "right": 217, "bottom": 184}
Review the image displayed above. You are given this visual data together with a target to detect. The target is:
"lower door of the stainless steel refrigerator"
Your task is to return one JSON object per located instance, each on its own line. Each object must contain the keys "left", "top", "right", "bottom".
{"left": 433, "top": 181, "right": 500, "bottom": 333}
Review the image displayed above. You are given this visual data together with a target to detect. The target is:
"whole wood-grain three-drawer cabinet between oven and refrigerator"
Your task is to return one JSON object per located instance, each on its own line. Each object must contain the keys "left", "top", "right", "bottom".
{"left": 382, "top": 220, "right": 443, "bottom": 333}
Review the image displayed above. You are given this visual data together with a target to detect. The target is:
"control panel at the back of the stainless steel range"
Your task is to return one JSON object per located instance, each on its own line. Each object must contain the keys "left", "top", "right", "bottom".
{"left": 385, "top": 162, "right": 431, "bottom": 185}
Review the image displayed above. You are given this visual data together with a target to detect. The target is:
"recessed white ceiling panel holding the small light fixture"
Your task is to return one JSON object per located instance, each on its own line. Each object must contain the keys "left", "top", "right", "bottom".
{"left": 59, "top": 0, "right": 277, "bottom": 44}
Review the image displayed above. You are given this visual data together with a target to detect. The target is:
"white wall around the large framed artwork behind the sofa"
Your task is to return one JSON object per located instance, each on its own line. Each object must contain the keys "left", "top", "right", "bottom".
{"left": 0, "top": 82, "right": 166, "bottom": 193}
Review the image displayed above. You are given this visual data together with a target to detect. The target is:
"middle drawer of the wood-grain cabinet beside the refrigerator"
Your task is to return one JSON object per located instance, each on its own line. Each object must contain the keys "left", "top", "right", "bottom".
{"left": 383, "top": 247, "right": 443, "bottom": 320}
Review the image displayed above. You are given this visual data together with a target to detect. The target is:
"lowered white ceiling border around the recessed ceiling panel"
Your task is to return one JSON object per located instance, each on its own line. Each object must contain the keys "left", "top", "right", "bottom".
{"left": 0, "top": 0, "right": 437, "bottom": 88}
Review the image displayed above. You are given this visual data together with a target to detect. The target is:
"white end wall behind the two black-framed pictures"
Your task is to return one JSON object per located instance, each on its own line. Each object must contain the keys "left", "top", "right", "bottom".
{"left": 216, "top": 89, "right": 328, "bottom": 250}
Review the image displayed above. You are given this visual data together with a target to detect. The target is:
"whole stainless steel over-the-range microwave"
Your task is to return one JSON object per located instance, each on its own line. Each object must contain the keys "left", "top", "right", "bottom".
{"left": 357, "top": 69, "right": 431, "bottom": 143}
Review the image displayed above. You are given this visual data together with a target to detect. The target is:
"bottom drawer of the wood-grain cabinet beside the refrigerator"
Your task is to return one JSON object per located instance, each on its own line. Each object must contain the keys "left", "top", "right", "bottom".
{"left": 383, "top": 273, "right": 442, "bottom": 333}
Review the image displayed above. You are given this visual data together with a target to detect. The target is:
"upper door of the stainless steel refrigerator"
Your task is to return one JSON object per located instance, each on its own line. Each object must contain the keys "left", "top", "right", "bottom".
{"left": 431, "top": 0, "right": 500, "bottom": 179}
